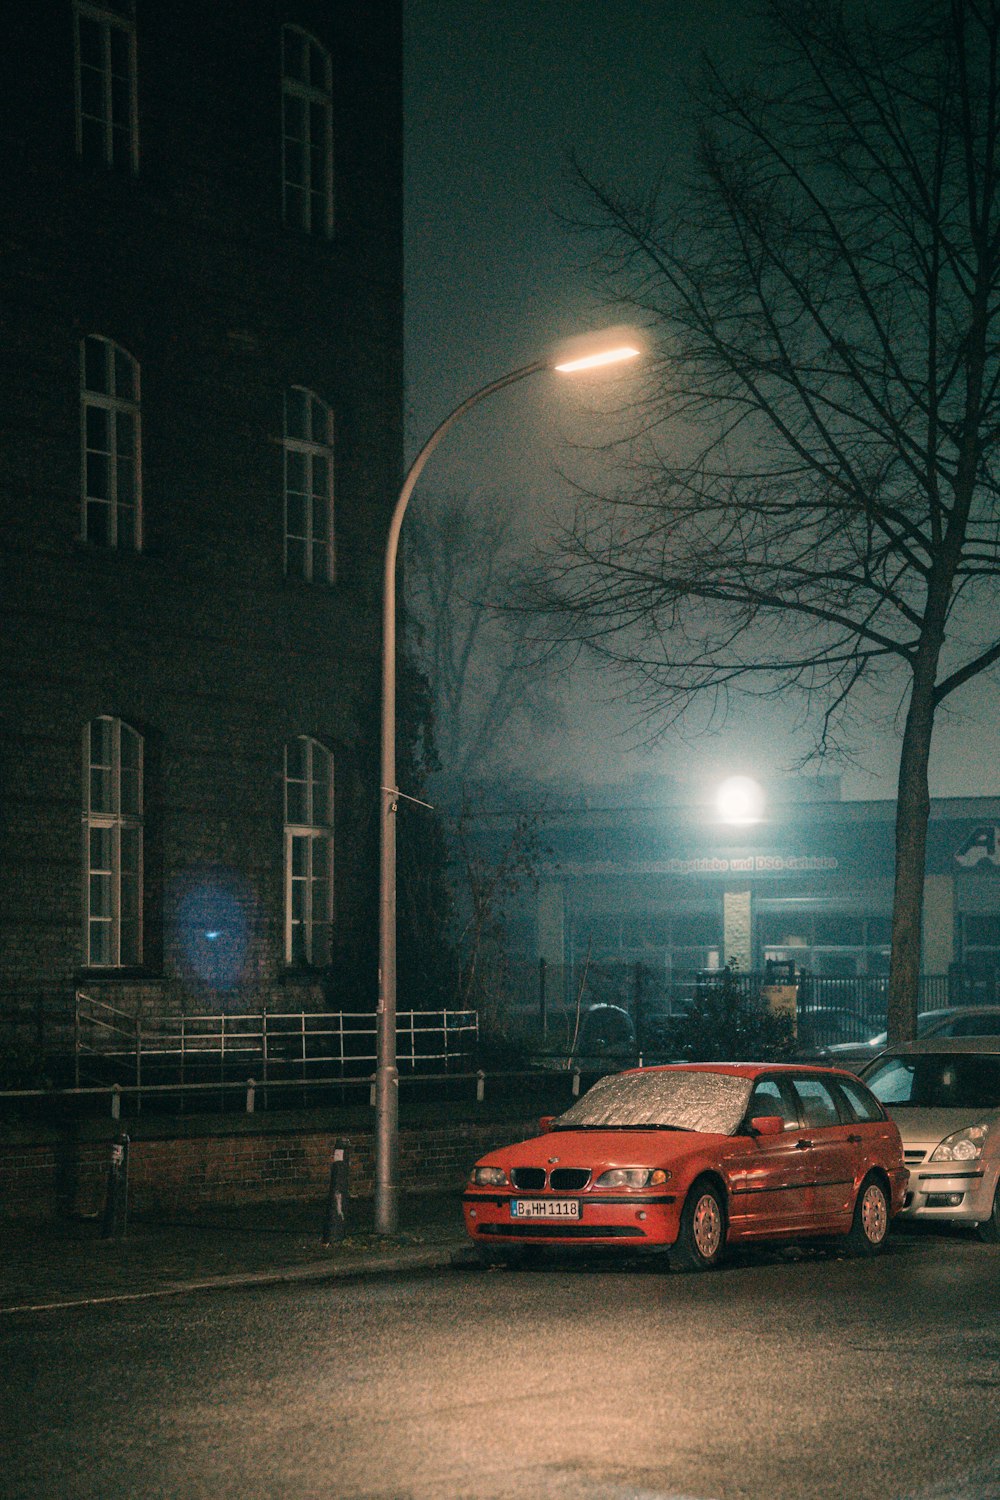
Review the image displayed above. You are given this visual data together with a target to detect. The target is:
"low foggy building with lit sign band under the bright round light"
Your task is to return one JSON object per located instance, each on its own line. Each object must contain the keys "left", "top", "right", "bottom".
{"left": 464, "top": 777, "right": 1000, "bottom": 1017}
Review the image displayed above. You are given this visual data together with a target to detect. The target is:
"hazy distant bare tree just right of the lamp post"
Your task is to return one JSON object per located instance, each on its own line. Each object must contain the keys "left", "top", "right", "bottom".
{"left": 405, "top": 495, "right": 559, "bottom": 785}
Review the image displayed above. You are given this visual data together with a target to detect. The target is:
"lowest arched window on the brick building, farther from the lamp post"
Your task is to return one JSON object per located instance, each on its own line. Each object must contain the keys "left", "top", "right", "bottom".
{"left": 84, "top": 716, "right": 142, "bottom": 969}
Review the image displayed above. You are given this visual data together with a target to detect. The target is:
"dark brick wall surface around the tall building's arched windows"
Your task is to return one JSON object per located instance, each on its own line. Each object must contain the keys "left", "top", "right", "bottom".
{"left": 0, "top": 0, "right": 402, "bottom": 1032}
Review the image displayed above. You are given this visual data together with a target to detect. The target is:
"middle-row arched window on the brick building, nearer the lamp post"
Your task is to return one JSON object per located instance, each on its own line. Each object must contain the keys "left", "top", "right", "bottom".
{"left": 285, "top": 386, "right": 333, "bottom": 582}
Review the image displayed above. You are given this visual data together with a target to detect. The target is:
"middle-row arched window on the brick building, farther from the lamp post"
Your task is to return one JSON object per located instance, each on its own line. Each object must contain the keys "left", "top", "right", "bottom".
{"left": 79, "top": 335, "right": 142, "bottom": 552}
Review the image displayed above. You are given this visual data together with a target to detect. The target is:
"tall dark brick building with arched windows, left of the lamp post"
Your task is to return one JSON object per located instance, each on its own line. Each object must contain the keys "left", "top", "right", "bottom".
{"left": 0, "top": 0, "right": 402, "bottom": 1046}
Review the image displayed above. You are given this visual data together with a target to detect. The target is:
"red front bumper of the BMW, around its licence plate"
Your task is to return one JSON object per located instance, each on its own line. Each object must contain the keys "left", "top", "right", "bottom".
{"left": 462, "top": 1190, "right": 682, "bottom": 1250}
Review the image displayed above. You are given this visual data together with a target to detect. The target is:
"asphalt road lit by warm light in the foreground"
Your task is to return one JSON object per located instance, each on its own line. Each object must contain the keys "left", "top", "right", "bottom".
{"left": 0, "top": 1235, "right": 1000, "bottom": 1500}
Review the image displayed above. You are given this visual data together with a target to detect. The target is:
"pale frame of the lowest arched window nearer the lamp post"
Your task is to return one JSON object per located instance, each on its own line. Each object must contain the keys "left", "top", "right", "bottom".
{"left": 282, "top": 735, "right": 336, "bottom": 969}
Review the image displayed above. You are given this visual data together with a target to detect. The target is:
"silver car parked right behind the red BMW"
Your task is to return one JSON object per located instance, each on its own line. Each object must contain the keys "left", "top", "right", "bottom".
{"left": 862, "top": 1037, "right": 1000, "bottom": 1245}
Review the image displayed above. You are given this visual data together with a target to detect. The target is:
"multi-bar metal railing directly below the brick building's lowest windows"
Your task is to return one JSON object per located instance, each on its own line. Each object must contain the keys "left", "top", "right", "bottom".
{"left": 73, "top": 992, "right": 478, "bottom": 1094}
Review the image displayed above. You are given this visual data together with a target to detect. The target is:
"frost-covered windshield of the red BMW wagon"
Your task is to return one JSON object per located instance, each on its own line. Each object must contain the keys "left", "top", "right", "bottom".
{"left": 555, "top": 1070, "right": 753, "bottom": 1136}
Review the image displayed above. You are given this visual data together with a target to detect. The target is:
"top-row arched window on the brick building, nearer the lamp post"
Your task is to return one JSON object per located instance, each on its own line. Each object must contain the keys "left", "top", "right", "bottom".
{"left": 282, "top": 26, "right": 333, "bottom": 237}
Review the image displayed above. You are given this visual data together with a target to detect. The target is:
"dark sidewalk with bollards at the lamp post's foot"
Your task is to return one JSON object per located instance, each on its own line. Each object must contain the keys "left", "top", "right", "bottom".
{"left": 0, "top": 1193, "right": 468, "bottom": 1316}
